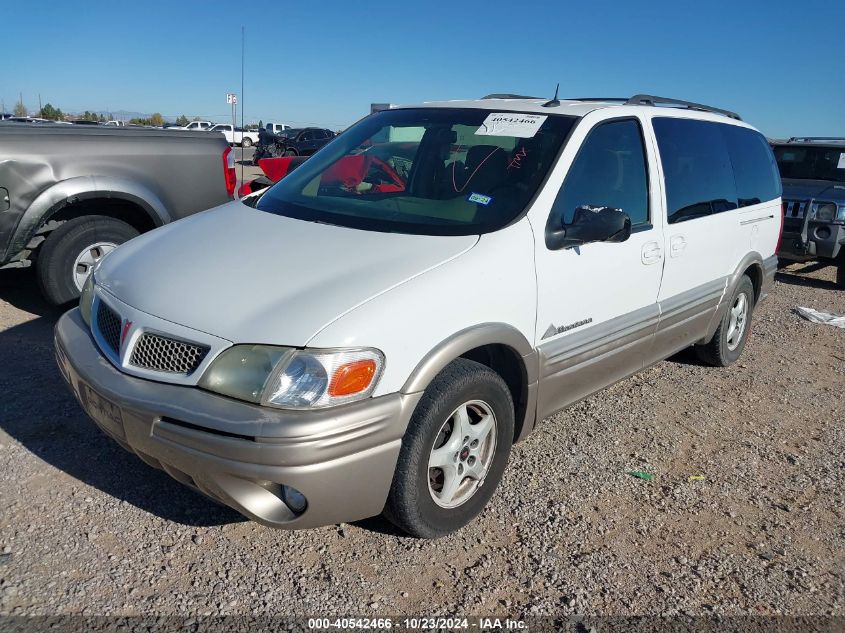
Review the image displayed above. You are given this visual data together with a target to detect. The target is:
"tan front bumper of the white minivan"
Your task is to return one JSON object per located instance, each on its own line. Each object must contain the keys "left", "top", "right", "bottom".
{"left": 55, "top": 309, "right": 422, "bottom": 529}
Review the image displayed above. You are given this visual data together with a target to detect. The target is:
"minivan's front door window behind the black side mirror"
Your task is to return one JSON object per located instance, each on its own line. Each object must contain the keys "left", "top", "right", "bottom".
{"left": 550, "top": 119, "right": 649, "bottom": 226}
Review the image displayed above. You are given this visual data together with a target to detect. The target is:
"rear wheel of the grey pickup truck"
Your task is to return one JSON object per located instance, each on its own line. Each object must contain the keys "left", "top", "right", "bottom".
{"left": 37, "top": 215, "right": 138, "bottom": 305}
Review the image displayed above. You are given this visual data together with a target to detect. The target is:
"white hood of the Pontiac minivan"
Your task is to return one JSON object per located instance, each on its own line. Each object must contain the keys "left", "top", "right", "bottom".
{"left": 96, "top": 202, "right": 478, "bottom": 346}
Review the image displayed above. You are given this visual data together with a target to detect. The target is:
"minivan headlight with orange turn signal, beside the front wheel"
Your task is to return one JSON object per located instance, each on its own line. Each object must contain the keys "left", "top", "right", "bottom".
{"left": 199, "top": 345, "right": 384, "bottom": 409}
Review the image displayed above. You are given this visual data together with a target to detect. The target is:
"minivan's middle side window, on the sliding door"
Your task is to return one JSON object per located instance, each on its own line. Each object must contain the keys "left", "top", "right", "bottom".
{"left": 652, "top": 117, "right": 738, "bottom": 224}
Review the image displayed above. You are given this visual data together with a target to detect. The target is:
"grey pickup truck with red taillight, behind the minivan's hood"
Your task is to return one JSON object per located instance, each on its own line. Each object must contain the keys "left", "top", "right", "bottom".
{"left": 0, "top": 123, "right": 236, "bottom": 304}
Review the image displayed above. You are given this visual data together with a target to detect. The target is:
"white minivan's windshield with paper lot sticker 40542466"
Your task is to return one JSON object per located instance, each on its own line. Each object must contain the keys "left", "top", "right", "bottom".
{"left": 256, "top": 108, "right": 577, "bottom": 235}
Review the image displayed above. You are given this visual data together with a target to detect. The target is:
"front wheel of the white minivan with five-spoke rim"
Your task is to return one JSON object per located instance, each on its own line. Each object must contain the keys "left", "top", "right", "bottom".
{"left": 384, "top": 358, "right": 514, "bottom": 538}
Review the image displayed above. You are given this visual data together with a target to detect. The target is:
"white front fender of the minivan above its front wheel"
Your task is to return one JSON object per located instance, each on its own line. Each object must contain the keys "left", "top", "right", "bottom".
{"left": 308, "top": 219, "right": 537, "bottom": 396}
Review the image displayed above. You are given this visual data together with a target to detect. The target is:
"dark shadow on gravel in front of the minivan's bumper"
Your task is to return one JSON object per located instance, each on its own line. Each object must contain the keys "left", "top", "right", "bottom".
{"left": 0, "top": 278, "right": 245, "bottom": 526}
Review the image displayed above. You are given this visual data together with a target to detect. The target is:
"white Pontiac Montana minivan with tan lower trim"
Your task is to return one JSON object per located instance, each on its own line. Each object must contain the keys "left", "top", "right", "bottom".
{"left": 51, "top": 95, "right": 782, "bottom": 537}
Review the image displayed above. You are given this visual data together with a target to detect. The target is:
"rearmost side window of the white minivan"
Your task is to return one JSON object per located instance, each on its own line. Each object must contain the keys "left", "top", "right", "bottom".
{"left": 719, "top": 125, "right": 781, "bottom": 207}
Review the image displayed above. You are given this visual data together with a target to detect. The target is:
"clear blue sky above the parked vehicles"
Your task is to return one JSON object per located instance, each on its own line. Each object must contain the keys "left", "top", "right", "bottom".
{"left": 0, "top": 0, "right": 845, "bottom": 136}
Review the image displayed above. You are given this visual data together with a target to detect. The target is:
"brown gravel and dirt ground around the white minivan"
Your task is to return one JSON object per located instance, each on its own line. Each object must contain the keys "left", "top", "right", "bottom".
{"left": 0, "top": 265, "right": 845, "bottom": 616}
